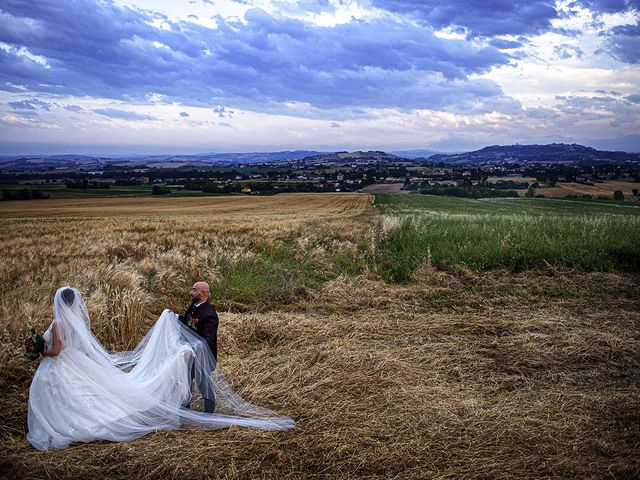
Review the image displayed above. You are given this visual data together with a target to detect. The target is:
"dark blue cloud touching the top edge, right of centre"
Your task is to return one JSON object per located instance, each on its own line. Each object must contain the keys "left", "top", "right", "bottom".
{"left": 372, "top": 0, "right": 558, "bottom": 37}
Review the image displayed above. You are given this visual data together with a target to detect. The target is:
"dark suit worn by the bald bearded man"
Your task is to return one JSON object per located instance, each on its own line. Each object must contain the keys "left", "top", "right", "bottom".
{"left": 178, "top": 300, "right": 218, "bottom": 413}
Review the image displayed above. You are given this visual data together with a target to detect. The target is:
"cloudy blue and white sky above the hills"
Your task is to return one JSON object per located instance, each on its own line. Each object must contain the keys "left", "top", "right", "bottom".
{"left": 0, "top": 0, "right": 640, "bottom": 155}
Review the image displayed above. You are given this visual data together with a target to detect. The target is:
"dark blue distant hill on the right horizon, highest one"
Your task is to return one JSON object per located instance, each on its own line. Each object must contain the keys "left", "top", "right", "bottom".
{"left": 428, "top": 143, "right": 640, "bottom": 164}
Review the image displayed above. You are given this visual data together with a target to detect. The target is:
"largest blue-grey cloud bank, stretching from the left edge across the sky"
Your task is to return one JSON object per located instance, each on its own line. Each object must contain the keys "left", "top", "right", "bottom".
{"left": 0, "top": 0, "right": 516, "bottom": 113}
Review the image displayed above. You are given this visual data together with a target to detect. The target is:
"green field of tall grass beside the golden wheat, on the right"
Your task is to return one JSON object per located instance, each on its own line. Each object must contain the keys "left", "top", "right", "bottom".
{"left": 375, "top": 195, "right": 640, "bottom": 282}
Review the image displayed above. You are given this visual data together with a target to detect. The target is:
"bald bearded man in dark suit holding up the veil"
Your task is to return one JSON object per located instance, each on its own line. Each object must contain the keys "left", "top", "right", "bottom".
{"left": 178, "top": 282, "right": 218, "bottom": 413}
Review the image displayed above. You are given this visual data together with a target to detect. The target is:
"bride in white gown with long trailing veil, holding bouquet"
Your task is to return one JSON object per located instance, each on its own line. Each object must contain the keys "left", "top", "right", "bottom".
{"left": 27, "top": 287, "right": 295, "bottom": 451}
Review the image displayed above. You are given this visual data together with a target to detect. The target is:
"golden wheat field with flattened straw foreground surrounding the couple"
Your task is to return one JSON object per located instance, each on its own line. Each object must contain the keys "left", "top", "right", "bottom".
{"left": 0, "top": 194, "right": 640, "bottom": 479}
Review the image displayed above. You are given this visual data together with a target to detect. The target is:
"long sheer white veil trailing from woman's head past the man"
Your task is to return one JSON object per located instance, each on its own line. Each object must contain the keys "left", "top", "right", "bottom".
{"left": 45, "top": 286, "right": 295, "bottom": 439}
